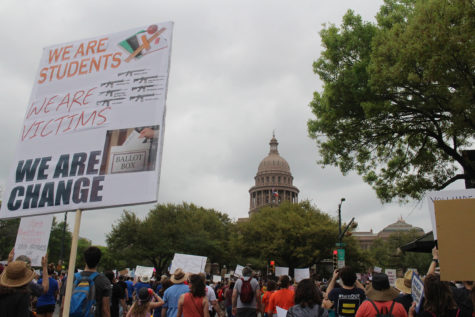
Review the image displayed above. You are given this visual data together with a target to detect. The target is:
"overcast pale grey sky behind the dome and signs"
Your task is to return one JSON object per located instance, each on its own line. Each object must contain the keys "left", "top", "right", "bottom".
{"left": 0, "top": 0, "right": 463, "bottom": 245}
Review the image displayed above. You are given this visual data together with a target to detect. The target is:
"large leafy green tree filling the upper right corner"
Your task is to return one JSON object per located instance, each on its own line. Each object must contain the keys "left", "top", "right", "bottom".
{"left": 308, "top": 0, "right": 475, "bottom": 202}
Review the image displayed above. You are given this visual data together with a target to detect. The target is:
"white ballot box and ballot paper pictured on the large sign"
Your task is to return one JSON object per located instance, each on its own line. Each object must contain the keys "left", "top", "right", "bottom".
{"left": 109, "top": 130, "right": 152, "bottom": 174}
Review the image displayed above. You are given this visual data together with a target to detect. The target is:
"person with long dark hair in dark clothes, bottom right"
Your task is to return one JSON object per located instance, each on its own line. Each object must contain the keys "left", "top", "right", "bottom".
{"left": 409, "top": 274, "right": 460, "bottom": 317}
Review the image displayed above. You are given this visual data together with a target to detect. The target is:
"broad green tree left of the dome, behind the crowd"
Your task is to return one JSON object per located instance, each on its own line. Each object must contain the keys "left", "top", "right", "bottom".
{"left": 107, "top": 203, "right": 232, "bottom": 272}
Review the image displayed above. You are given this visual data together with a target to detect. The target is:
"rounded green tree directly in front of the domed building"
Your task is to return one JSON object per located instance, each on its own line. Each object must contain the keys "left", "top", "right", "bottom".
{"left": 234, "top": 201, "right": 364, "bottom": 270}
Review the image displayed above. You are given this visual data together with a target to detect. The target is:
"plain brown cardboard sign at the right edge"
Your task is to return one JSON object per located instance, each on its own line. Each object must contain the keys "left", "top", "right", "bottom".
{"left": 434, "top": 199, "right": 475, "bottom": 281}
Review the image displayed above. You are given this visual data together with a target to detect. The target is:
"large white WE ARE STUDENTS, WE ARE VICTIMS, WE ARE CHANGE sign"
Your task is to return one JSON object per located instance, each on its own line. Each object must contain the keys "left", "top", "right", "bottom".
{"left": 0, "top": 22, "right": 173, "bottom": 218}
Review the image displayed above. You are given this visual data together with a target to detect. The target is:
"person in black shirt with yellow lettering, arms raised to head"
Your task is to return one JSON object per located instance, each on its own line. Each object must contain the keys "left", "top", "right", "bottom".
{"left": 323, "top": 266, "right": 366, "bottom": 317}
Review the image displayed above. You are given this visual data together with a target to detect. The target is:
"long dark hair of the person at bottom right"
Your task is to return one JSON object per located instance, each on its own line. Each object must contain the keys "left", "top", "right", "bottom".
{"left": 424, "top": 274, "right": 457, "bottom": 317}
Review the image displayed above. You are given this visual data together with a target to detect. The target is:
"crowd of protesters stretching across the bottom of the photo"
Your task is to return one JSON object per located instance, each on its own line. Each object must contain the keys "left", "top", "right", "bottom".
{"left": 0, "top": 247, "right": 475, "bottom": 317}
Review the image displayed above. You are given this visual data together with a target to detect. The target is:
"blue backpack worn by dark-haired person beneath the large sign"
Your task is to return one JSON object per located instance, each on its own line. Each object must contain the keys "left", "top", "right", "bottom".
{"left": 69, "top": 272, "right": 99, "bottom": 317}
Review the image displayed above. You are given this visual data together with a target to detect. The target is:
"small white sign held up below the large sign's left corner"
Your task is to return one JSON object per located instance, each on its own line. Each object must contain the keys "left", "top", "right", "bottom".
{"left": 15, "top": 215, "right": 53, "bottom": 266}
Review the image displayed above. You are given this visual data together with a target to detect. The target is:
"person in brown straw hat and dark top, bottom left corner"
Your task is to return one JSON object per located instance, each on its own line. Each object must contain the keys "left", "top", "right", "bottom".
{"left": 0, "top": 261, "right": 35, "bottom": 317}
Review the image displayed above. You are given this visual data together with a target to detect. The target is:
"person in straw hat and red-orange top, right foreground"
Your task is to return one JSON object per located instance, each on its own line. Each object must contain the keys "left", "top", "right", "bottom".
{"left": 356, "top": 273, "right": 407, "bottom": 317}
